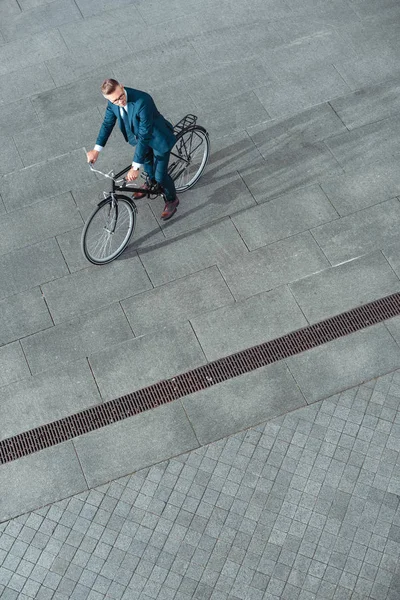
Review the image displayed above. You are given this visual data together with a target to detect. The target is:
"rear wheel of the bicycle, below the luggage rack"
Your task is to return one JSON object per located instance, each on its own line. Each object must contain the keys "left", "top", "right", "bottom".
{"left": 168, "top": 125, "right": 210, "bottom": 192}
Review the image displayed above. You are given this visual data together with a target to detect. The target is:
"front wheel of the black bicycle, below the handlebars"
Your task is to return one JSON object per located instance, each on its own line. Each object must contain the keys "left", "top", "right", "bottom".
{"left": 81, "top": 195, "right": 136, "bottom": 265}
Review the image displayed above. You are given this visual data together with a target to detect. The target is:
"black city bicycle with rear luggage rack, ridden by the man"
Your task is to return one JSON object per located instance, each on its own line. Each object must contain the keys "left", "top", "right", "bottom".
{"left": 81, "top": 114, "right": 210, "bottom": 265}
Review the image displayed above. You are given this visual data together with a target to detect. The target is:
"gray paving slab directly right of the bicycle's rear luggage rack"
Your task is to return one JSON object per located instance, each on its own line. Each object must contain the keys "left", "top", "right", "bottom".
{"left": 195, "top": 91, "right": 270, "bottom": 140}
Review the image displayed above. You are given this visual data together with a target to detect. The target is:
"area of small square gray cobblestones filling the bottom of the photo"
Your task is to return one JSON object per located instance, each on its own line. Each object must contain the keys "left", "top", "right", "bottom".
{"left": 0, "top": 372, "right": 400, "bottom": 600}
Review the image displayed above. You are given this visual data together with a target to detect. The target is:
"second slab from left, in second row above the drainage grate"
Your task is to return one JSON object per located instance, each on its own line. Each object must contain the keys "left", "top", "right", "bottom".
{"left": 21, "top": 304, "right": 134, "bottom": 374}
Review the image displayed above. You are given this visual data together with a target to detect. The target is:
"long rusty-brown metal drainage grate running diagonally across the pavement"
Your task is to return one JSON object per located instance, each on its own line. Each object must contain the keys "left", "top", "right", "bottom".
{"left": 0, "top": 293, "right": 400, "bottom": 464}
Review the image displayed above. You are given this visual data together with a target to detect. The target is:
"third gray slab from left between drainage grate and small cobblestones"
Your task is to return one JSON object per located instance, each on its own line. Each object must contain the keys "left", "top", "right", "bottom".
{"left": 182, "top": 362, "right": 305, "bottom": 445}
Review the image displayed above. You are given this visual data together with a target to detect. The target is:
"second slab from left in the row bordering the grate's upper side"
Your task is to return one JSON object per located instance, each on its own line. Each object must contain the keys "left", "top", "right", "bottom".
{"left": 89, "top": 323, "right": 206, "bottom": 400}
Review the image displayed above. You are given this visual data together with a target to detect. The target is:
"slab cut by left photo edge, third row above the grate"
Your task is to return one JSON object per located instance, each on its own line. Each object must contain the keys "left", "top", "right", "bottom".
{"left": 0, "top": 288, "right": 53, "bottom": 346}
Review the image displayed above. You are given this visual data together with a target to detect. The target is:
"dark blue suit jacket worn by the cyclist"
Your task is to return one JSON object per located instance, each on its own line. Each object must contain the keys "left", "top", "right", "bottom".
{"left": 96, "top": 88, "right": 176, "bottom": 164}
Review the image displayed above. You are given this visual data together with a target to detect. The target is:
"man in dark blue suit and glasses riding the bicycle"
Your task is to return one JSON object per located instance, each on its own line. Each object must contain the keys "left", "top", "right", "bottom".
{"left": 87, "top": 79, "right": 179, "bottom": 221}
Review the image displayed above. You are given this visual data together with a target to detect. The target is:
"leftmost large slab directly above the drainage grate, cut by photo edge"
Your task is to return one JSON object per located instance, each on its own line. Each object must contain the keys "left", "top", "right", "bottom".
{"left": 0, "top": 359, "right": 101, "bottom": 439}
